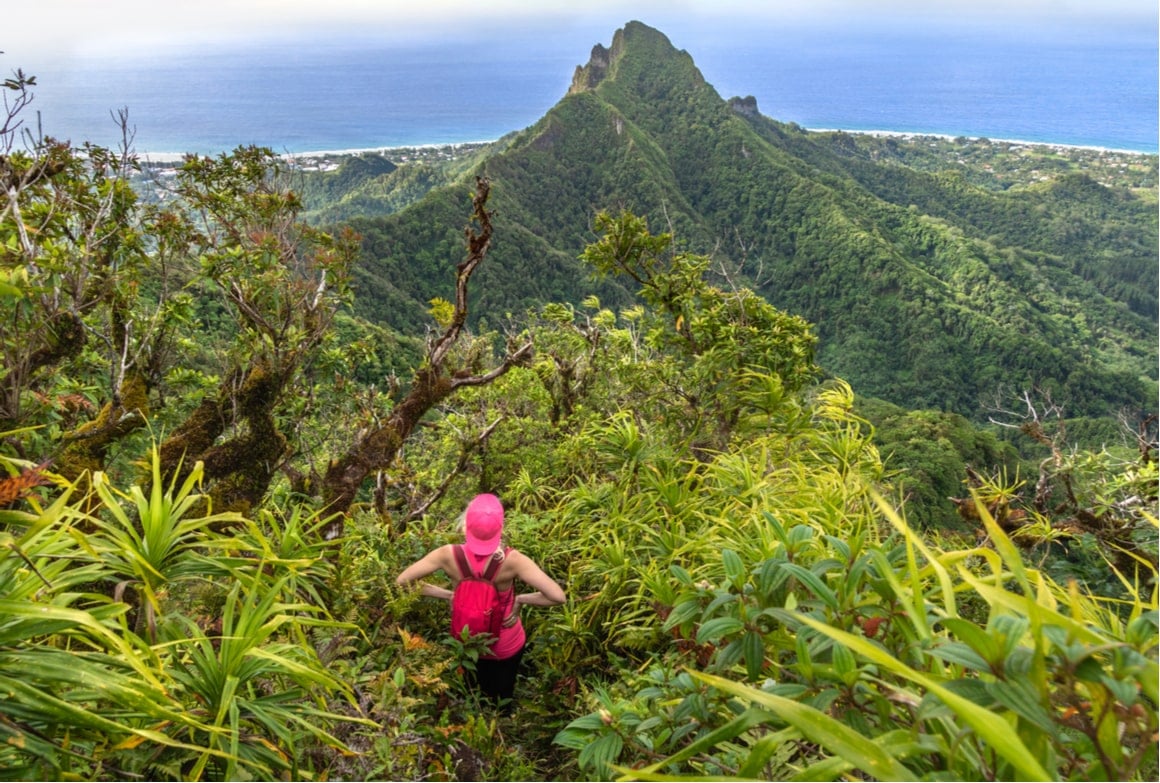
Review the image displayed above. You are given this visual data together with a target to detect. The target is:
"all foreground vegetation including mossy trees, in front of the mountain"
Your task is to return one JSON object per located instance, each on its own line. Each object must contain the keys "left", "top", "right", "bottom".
{"left": 0, "top": 64, "right": 1160, "bottom": 781}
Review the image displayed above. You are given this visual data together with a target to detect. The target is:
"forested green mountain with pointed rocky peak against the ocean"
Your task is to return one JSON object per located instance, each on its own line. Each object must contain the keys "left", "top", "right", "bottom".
{"left": 327, "top": 22, "right": 1158, "bottom": 416}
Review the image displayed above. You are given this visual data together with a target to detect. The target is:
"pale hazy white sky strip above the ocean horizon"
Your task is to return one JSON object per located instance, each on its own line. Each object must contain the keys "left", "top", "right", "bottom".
{"left": 0, "top": 0, "right": 1158, "bottom": 66}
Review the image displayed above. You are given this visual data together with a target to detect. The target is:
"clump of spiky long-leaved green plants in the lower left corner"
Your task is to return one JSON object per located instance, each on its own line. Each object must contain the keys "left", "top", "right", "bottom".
{"left": 0, "top": 450, "right": 364, "bottom": 780}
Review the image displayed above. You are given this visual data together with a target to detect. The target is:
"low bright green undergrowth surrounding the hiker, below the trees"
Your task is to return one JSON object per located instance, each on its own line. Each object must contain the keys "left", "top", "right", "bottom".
{"left": 0, "top": 380, "right": 1157, "bottom": 780}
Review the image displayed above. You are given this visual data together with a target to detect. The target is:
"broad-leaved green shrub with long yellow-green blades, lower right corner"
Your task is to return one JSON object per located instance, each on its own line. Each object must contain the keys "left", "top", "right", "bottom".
{"left": 557, "top": 494, "right": 1158, "bottom": 780}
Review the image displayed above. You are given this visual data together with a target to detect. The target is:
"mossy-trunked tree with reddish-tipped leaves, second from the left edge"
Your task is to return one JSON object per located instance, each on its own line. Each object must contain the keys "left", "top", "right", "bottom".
{"left": 151, "top": 147, "right": 357, "bottom": 510}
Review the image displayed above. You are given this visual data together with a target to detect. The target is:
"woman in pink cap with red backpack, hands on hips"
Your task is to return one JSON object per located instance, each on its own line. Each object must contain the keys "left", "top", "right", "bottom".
{"left": 396, "top": 494, "right": 564, "bottom": 701}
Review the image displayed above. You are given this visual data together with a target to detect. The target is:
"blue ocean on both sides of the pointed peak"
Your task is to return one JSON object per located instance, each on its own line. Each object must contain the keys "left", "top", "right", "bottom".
{"left": 18, "top": 18, "right": 1160, "bottom": 154}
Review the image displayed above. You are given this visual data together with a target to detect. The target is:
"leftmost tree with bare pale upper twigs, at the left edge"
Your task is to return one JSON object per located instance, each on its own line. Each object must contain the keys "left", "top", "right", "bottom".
{"left": 0, "top": 71, "right": 160, "bottom": 468}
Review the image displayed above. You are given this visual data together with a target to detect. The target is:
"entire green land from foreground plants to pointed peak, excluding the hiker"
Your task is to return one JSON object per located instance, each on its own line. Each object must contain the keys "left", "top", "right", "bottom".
{"left": 0, "top": 22, "right": 1160, "bottom": 781}
